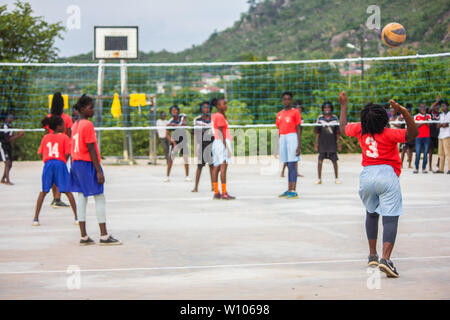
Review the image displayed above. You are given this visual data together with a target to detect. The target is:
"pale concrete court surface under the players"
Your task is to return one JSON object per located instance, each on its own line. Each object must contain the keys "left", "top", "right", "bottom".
{"left": 0, "top": 155, "right": 450, "bottom": 299}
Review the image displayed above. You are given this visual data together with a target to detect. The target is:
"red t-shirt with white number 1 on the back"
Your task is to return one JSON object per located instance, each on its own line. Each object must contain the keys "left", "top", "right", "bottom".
{"left": 71, "top": 119, "right": 100, "bottom": 163}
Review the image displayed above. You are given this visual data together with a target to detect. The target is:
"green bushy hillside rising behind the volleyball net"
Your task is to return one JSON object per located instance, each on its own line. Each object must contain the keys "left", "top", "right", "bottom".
{"left": 62, "top": 0, "right": 450, "bottom": 62}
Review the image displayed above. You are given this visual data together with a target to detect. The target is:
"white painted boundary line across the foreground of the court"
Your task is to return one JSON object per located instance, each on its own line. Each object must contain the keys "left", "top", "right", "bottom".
{"left": 0, "top": 256, "right": 450, "bottom": 276}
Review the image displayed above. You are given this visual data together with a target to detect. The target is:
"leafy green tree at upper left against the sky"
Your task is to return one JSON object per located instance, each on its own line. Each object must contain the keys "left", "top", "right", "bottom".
{"left": 0, "top": 0, "right": 65, "bottom": 62}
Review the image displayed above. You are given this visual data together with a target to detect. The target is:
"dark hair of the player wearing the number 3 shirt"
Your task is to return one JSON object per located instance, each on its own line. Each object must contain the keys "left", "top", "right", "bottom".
{"left": 361, "top": 102, "right": 389, "bottom": 136}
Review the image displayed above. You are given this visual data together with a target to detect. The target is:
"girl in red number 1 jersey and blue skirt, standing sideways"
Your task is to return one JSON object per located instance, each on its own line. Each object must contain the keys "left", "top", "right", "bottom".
{"left": 70, "top": 94, "right": 122, "bottom": 246}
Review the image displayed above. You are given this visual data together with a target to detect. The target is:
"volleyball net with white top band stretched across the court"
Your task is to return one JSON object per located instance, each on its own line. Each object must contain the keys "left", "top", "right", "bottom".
{"left": 0, "top": 53, "right": 450, "bottom": 131}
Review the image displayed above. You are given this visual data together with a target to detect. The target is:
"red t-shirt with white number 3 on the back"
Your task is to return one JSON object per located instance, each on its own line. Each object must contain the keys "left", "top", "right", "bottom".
{"left": 345, "top": 122, "right": 406, "bottom": 176}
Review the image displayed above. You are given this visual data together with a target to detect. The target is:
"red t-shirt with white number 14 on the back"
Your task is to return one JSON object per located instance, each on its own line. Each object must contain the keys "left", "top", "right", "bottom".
{"left": 38, "top": 133, "right": 70, "bottom": 162}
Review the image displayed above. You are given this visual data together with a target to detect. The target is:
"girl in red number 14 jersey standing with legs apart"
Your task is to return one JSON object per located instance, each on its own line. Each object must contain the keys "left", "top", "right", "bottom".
{"left": 33, "top": 115, "right": 78, "bottom": 226}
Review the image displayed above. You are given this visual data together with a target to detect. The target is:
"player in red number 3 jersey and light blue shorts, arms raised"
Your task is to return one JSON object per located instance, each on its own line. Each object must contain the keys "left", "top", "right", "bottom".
{"left": 339, "top": 91, "right": 419, "bottom": 278}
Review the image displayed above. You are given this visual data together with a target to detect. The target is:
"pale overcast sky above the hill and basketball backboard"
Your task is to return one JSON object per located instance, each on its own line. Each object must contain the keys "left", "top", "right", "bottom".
{"left": 2, "top": 0, "right": 248, "bottom": 57}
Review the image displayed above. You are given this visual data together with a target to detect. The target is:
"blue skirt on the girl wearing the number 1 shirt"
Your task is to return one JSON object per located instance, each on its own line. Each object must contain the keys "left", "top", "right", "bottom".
{"left": 70, "top": 160, "right": 103, "bottom": 197}
